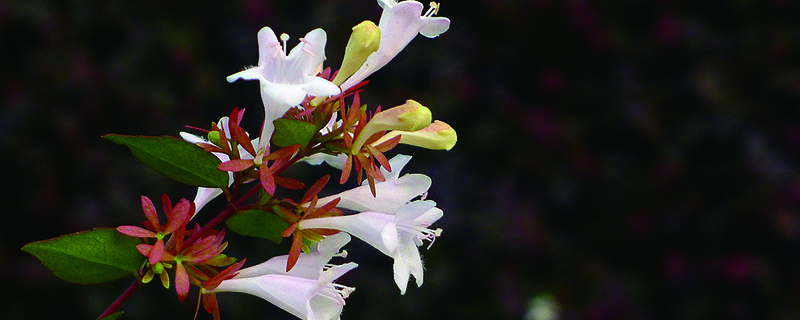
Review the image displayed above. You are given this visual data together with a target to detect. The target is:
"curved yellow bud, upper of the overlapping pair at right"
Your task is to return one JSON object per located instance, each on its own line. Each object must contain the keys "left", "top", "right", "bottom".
{"left": 350, "top": 99, "right": 432, "bottom": 154}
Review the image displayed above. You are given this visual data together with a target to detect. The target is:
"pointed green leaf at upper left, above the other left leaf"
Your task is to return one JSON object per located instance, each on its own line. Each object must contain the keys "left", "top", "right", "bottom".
{"left": 103, "top": 134, "right": 228, "bottom": 188}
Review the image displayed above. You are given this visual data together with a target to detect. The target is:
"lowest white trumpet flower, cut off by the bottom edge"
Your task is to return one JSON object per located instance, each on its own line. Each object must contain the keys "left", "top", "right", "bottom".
{"left": 206, "top": 262, "right": 358, "bottom": 320}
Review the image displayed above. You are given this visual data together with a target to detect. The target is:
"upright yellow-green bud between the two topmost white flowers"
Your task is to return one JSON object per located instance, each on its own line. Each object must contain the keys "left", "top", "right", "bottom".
{"left": 331, "top": 20, "right": 381, "bottom": 86}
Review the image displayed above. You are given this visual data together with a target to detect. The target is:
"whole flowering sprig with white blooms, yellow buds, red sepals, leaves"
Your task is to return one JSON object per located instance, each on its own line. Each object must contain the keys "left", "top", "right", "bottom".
{"left": 29, "top": 0, "right": 457, "bottom": 319}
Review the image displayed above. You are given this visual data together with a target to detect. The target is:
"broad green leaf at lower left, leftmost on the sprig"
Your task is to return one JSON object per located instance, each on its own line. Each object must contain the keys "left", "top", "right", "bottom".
{"left": 22, "top": 228, "right": 145, "bottom": 284}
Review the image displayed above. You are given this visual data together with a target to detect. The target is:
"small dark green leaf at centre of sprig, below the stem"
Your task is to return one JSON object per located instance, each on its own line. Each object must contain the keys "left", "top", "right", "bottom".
{"left": 225, "top": 209, "right": 289, "bottom": 243}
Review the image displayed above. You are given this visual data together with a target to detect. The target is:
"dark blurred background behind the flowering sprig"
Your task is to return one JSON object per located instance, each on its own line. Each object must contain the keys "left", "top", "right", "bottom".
{"left": 0, "top": 0, "right": 800, "bottom": 320}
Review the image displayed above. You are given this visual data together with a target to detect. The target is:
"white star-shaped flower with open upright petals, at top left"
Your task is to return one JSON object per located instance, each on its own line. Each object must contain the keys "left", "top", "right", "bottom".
{"left": 228, "top": 27, "right": 341, "bottom": 147}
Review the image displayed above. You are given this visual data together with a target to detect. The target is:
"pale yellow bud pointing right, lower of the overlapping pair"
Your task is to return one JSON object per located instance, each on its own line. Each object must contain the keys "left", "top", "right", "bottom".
{"left": 372, "top": 120, "right": 458, "bottom": 150}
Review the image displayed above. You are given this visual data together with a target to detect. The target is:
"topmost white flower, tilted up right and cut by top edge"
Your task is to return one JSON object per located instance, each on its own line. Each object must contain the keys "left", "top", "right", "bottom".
{"left": 342, "top": 0, "right": 450, "bottom": 90}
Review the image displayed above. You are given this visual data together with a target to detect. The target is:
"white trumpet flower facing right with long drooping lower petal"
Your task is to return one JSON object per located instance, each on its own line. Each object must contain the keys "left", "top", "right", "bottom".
{"left": 297, "top": 200, "right": 443, "bottom": 294}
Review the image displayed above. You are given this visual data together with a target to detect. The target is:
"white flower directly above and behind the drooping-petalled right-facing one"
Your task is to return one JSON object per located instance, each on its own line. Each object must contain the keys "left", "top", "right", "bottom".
{"left": 318, "top": 154, "right": 431, "bottom": 214}
